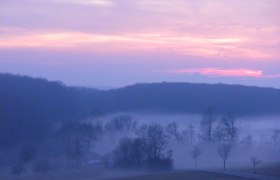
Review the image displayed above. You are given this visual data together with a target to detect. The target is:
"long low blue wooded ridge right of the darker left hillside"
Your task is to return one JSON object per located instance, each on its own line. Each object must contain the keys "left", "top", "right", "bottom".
{"left": 101, "top": 83, "right": 280, "bottom": 114}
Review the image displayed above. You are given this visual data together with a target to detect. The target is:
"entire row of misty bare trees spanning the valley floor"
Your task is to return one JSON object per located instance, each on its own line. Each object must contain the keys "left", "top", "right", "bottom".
{"left": 7, "top": 113, "right": 280, "bottom": 175}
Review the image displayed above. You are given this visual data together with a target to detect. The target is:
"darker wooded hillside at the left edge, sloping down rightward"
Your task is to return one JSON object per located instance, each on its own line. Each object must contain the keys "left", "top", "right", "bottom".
{"left": 0, "top": 74, "right": 101, "bottom": 147}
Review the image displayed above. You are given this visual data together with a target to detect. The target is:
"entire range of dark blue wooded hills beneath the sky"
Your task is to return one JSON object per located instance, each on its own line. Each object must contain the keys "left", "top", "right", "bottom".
{"left": 0, "top": 74, "right": 280, "bottom": 145}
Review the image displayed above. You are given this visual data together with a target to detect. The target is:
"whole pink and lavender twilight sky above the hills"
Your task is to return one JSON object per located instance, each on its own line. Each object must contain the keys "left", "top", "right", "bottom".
{"left": 0, "top": 0, "right": 280, "bottom": 89}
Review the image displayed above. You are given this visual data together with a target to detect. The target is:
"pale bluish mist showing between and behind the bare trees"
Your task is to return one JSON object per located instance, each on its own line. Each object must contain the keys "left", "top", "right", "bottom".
{"left": 89, "top": 112, "right": 280, "bottom": 169}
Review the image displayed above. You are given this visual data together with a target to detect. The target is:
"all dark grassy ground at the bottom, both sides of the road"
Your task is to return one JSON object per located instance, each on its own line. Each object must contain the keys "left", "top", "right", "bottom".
{"left": 0, "top": 163, "right": 280, "bottom": 180}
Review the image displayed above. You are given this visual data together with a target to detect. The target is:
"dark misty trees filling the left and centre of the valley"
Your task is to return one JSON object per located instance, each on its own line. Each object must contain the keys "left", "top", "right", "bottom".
{"left": 7, "top": 115, "right": 173, "bottom": 175}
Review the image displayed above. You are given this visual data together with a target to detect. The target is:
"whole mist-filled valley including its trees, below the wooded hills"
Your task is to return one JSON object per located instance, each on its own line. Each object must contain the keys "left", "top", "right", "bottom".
{"left": 1, "top": 109, "right": 280, "bottom": 179}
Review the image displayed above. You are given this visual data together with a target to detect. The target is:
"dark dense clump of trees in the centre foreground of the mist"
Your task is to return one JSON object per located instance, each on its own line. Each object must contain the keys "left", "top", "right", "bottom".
{"left": 113, "top": 124, "right": 172, "bottom": 169}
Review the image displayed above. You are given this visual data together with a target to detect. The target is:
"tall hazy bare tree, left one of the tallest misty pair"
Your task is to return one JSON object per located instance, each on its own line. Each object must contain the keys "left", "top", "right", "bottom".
{"left": 200, "top": 107, "right": 217, "bottom": 144}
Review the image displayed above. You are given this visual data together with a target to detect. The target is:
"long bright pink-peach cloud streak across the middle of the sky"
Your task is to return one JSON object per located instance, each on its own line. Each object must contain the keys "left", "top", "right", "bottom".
{"left": 0, "top": 29, "right": 278, "bottom": 59}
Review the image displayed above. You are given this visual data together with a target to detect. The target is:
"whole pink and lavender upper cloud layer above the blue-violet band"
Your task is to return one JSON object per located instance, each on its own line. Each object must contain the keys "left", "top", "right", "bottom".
{"left": 0, "top": 0, "right": 280, "bottom": 61}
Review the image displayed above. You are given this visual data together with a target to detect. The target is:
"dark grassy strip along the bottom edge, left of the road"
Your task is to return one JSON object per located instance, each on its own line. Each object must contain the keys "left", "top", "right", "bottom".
{"left": 0, "top": 169, "right": 249, "bottom": 180}
